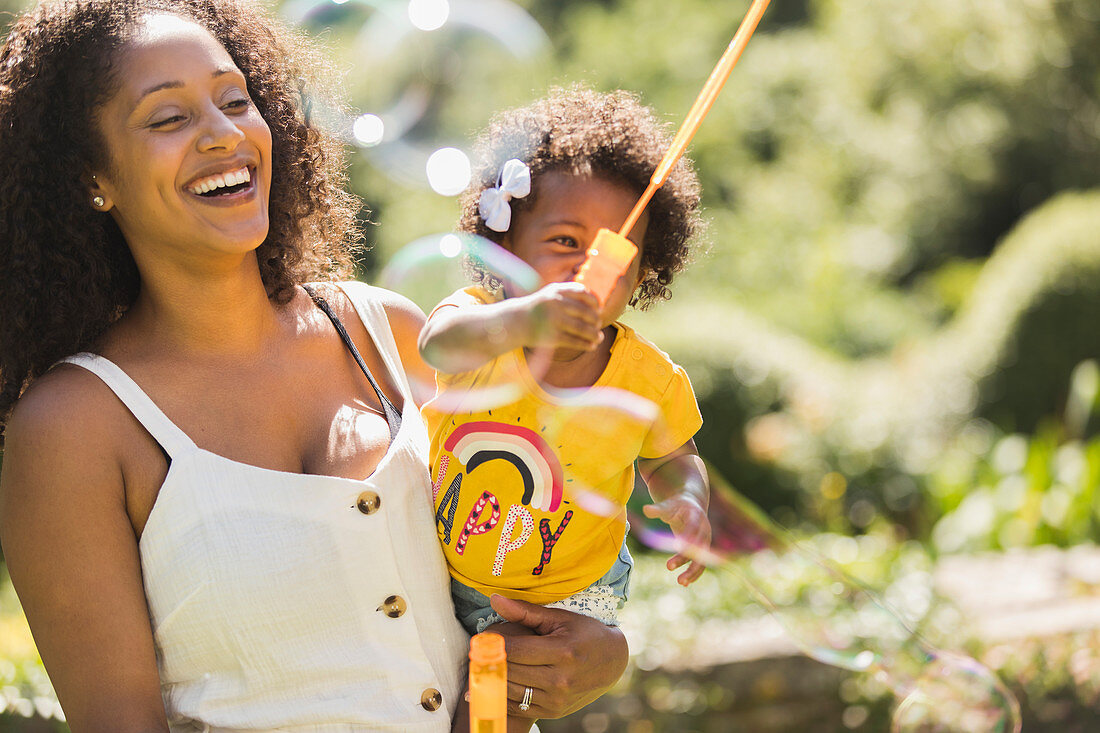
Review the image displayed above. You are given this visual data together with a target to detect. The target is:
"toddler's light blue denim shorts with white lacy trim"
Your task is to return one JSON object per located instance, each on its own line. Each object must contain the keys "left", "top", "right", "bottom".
{"left": 451, "top": 539, "right": 634, "bottom": 634}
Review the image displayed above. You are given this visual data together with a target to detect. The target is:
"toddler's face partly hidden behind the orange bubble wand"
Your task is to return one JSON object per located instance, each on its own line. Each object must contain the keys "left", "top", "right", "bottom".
{"left": 504, "top": 172, "right": 649, "bottom": 326}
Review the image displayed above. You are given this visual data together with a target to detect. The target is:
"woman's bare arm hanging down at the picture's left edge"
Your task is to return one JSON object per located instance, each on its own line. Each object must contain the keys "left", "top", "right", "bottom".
{"left": 0, "top": 368, "right": 168, "bottom": 733}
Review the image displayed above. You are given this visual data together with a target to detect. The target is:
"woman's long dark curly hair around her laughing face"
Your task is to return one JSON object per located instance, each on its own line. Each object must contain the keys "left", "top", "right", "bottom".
{"left": 0, "top": 0, "right": 359, "bottom": 436}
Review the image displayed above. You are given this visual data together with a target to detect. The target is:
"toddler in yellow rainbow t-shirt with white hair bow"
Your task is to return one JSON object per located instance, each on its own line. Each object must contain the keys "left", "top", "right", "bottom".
{"left": 420, "top": 89, "right": 711, "bottom": 633}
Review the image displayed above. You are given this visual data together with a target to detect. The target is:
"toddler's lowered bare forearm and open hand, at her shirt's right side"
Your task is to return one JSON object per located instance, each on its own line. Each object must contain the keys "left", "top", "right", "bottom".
{"left": 638, "top": 440, "right": 711, "bottom": 586}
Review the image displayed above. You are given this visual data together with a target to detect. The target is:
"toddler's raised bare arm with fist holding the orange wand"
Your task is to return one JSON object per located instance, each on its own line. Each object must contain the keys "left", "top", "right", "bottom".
{"left": 419, "top": 282, "right": 603, "bottom": 374}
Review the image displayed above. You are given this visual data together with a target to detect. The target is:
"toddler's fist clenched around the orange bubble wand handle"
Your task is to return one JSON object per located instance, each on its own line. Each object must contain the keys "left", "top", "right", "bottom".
{"left": 524, "top": 282, "right": 603, "bottom": 351}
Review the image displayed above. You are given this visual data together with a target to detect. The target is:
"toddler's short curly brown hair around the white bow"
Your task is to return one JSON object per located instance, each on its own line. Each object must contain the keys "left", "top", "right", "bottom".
{"left": 459, "top": 87, "right": 702, "bottom": 309}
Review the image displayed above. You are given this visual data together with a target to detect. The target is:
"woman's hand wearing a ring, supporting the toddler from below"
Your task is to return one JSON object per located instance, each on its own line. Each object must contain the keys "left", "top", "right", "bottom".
{"left": 492, "top": 595, "right": 627, "bottom": 719}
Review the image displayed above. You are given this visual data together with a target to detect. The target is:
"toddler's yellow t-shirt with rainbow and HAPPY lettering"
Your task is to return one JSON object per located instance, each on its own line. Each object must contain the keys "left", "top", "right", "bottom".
{"left": 422, "top": 287, "right": 703, "bottom": 603}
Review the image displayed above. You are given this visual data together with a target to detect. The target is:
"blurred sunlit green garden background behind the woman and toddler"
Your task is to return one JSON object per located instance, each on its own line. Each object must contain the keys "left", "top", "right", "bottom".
{"left": 0, "top": 0, "right": 1100, "bottom": 733}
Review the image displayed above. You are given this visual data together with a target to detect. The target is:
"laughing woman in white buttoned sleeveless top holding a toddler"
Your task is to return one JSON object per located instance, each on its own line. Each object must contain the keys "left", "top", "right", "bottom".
{"left": 0, "top": 0, "right": 626, "bottom": 733}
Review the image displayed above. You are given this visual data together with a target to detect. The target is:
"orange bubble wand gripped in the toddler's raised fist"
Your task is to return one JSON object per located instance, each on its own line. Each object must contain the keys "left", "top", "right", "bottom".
{"left": 575, "top": 0, "right": 770, "bottom": 304}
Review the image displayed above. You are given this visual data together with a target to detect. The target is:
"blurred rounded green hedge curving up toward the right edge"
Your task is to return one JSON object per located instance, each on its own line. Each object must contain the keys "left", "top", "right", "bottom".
{"left": 653, "top": 194, "right": 1100, "bottom": 528}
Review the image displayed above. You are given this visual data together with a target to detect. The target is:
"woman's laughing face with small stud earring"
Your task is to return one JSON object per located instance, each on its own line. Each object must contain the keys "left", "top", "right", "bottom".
{"left": 91, "top": 14, "right": 272, "bottom": 264}
